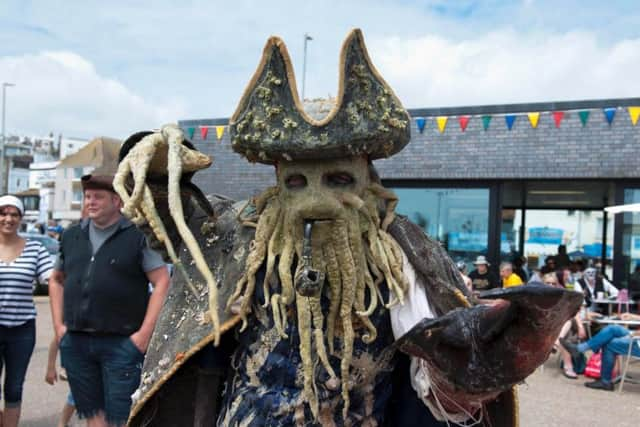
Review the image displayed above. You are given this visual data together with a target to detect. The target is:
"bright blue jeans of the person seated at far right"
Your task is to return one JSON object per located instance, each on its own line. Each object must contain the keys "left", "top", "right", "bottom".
{"left": 587, "top": 325, "right": 640, "bottom": 383}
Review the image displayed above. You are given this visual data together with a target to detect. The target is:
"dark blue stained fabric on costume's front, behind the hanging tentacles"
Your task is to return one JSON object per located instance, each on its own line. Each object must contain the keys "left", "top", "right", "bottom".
{"left": 218, "top": 270, "right": 400, "bottom": 426}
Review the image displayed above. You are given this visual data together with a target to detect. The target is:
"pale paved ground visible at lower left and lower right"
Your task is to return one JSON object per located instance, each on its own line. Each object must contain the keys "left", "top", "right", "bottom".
{"left": 12, "top": 297, "right": 640, "bottom": 427}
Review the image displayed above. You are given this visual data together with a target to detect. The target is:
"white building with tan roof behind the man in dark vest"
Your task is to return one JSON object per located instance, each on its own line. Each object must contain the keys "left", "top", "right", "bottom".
{"left": 53, "top": 137, "right": 120, "bottom": 227}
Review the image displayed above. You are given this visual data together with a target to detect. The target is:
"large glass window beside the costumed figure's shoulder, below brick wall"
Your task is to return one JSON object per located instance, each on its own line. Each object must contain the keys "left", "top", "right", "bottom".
{"left": 393, "top": 188, "right": 489, "bottom": 271}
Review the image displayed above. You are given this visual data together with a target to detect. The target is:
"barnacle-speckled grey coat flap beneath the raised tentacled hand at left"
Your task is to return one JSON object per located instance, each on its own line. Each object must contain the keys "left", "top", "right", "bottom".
{"left": 131, "top": 197, "right": 254, "bottom": 418}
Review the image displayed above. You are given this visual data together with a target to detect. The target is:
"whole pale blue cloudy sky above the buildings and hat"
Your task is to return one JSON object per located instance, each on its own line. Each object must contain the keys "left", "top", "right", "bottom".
{"left": 0, "top": 0, "right": 640, "bottom": 138}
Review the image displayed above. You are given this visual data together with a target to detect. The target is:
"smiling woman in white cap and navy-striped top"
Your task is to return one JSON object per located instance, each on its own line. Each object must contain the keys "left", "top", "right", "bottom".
{"left": 0, "top": 196, "right": 53, "bottom": 427}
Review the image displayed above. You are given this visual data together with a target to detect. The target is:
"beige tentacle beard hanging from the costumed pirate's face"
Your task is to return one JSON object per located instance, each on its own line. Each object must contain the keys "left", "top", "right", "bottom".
{"left": 227, "top": 184, "right": 407, "bottom": 419}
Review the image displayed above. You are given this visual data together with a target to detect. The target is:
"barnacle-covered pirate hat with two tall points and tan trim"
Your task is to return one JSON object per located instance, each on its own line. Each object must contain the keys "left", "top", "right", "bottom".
{"left": 229, "top": 29, "right": 410, "bottom": 164}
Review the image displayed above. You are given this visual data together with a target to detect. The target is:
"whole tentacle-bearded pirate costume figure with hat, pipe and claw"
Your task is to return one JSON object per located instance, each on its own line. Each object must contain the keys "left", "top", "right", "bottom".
{"left": 114, "top": 30, "right": 582, "bottom": 427}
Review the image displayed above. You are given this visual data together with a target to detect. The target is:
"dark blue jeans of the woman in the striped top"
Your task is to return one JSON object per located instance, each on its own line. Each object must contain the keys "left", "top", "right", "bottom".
{"left": 0, "top": 319, "right": 36, "bottom": 408}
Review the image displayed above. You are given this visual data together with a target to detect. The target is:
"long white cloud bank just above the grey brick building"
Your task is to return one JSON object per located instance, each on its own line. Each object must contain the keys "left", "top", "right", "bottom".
{"left": 370, "top": 29, "right": 640, "bottom": 107}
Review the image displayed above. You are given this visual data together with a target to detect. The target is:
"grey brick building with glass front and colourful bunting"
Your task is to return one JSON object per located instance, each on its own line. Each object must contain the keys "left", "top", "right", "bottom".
{"left": 180, "top": 98, "right": 640, "bottom": 286}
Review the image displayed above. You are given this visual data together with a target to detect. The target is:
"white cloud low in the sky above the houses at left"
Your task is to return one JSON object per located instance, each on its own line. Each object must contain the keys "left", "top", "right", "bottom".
{"left": 0, "top": 51, "right": 186, "bottom": 138}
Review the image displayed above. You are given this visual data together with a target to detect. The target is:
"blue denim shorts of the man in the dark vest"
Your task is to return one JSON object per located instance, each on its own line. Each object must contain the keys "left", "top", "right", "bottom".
{"left": 60, "top": 332, "right": 144, "bottom": 425}
